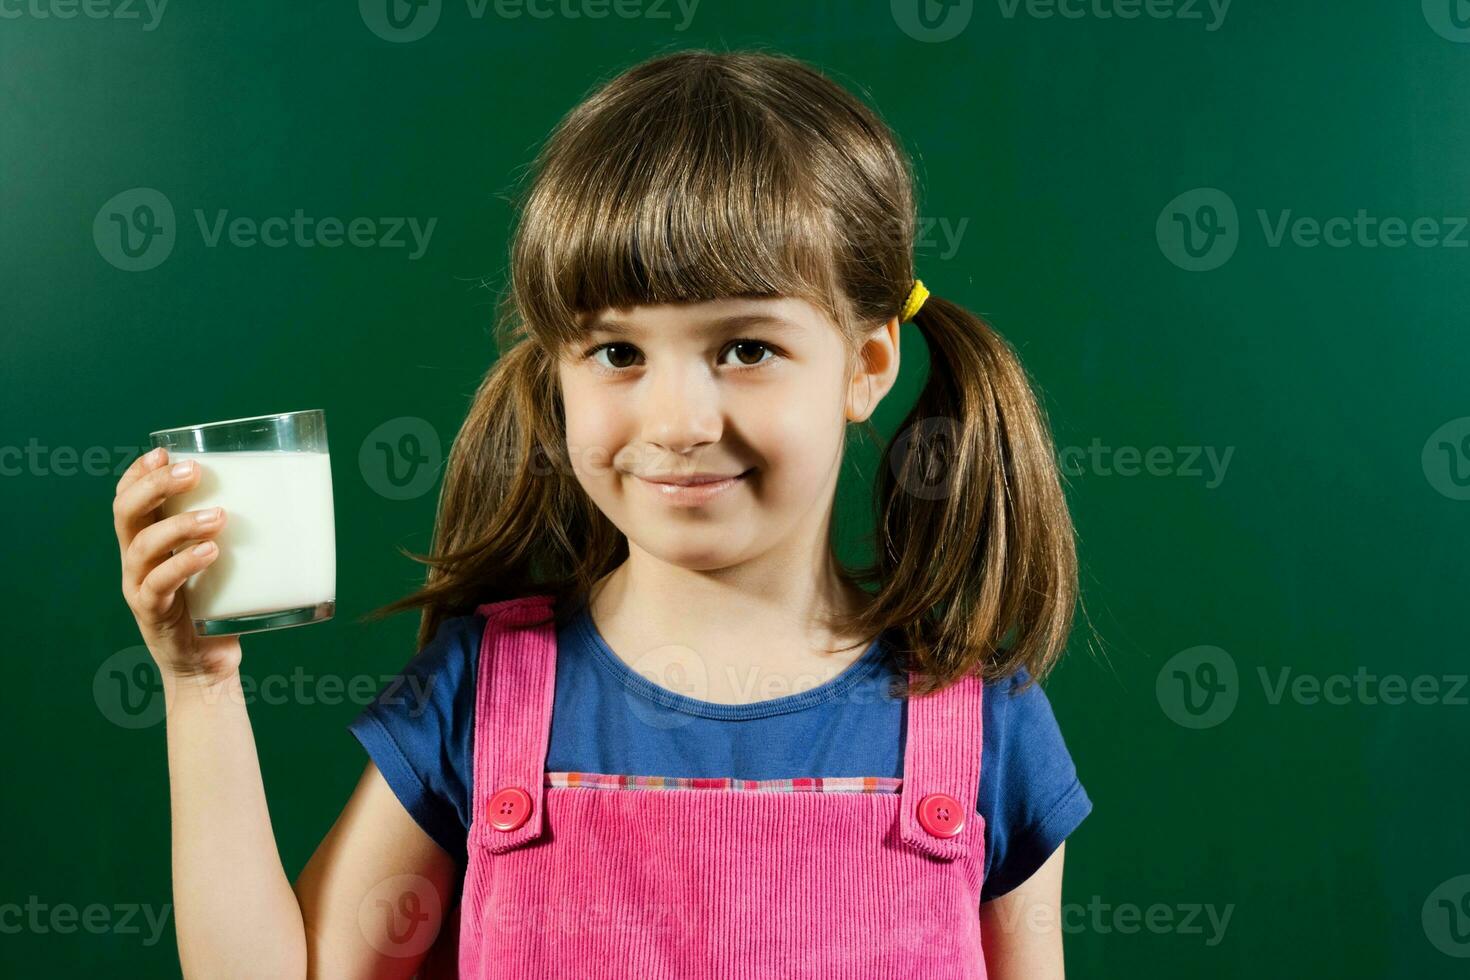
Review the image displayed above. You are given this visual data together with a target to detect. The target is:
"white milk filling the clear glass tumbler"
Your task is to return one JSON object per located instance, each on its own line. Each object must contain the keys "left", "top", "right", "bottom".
{"left": 163, "top": 450, "right": 337, "bottom": 620}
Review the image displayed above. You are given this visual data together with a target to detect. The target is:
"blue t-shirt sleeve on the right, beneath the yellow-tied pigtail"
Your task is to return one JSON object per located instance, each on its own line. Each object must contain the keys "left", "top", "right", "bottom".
{"left": 978, "top": 669, "right": 1092, "bottom": 902}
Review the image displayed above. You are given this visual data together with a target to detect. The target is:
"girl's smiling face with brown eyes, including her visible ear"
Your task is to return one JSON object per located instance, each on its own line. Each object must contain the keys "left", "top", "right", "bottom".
{"left": 557, "top": 297, "right": 898, "bottom": 570}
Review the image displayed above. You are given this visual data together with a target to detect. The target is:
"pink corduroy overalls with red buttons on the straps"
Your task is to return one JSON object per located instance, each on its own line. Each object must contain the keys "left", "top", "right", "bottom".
{"left": 441, "top": 595, "right": 985, "bottom": 980}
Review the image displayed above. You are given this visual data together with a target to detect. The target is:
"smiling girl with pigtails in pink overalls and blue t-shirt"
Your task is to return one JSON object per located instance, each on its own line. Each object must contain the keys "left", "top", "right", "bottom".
{"left": 113, "top": 51, "right": 1091, "bottom": 980}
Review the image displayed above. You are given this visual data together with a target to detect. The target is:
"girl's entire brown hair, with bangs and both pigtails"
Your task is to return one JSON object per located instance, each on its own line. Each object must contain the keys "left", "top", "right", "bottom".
{"left": 360, "top": 50, "right": 1078, "bottom": 696}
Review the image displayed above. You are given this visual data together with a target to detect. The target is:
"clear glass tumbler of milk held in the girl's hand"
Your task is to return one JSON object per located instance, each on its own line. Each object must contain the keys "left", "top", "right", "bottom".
{"left": 148, "top": 408, "right": 337, "bottom": 636}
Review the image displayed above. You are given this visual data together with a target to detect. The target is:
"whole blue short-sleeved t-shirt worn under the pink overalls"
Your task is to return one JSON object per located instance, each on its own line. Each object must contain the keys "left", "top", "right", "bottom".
{"left": 348, "top": 604, "right": 1092, "bottom": 901}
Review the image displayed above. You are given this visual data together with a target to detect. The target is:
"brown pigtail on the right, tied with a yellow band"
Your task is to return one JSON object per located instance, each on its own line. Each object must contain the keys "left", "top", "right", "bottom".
{"left": 864, "top": 295, "right": 1078, "bottom": 696}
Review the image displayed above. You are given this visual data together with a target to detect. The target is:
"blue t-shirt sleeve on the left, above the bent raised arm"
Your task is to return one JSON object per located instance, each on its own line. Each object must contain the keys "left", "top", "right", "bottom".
{"left": 347, "top": 616, "right": 485, "bottom": 867}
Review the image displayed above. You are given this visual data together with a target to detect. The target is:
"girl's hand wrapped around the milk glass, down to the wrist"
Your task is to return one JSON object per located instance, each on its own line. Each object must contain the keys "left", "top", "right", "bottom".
{"left": 112, "top": 448, "right": 240, "bottom": 683}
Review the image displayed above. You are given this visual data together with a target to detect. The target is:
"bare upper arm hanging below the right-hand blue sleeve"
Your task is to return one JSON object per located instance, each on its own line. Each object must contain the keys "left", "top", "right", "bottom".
{"left": 980, "top": 843, "right": 1067, "bottom": 980}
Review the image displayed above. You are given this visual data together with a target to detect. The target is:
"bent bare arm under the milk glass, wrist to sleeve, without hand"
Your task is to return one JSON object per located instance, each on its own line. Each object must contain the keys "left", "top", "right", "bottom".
{"left": 166, "top": 674, "right": 456, "bottom": 980}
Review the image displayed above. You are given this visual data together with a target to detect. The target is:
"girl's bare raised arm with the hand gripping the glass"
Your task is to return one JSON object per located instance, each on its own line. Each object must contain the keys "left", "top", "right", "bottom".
{"left": 112, "top": 451, "right": 454, "bottom": 980}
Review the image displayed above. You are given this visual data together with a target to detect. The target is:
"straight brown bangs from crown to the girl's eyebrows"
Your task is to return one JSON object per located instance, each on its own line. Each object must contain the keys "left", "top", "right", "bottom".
{"left": 515, "top": 66, "right": 844, "bottom": 345}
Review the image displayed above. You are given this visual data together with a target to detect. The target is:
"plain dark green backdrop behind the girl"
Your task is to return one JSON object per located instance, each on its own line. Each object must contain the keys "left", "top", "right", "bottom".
{"left": 0, "top": 0, "right": 1470, "bottom": 979}
